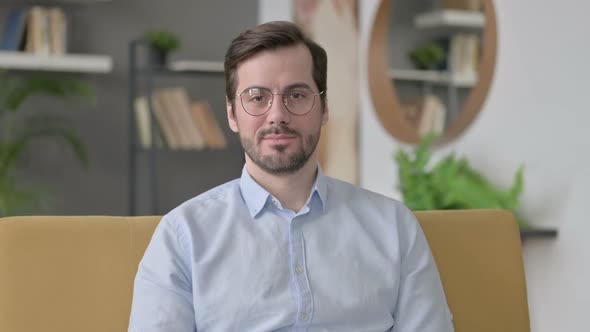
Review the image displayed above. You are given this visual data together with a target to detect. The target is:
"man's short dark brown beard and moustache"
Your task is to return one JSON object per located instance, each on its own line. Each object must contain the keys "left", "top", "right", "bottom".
{"left": 240, "top": 126, "right": 320, "bottom": 175}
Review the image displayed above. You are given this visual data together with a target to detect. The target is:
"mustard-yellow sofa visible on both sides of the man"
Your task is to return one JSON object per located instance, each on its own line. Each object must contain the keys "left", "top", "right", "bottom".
{"left": 0, "top": 210, "right": 530, "bottom": 332}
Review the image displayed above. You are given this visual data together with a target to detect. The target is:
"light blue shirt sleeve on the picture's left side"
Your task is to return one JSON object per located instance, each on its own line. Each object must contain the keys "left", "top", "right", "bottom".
{"left": 129, "top": 216, "right": 197, "bottom": 332}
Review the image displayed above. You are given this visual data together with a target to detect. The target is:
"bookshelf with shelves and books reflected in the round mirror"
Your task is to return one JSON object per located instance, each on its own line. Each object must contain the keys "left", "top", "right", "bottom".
{"left": 389, "top": 9, "right": 485, "bottom": 138}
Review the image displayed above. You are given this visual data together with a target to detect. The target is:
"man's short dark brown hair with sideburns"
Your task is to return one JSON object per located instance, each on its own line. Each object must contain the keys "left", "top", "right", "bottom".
{"left": 224, "top": 21, "right": 328, "bottom": 111}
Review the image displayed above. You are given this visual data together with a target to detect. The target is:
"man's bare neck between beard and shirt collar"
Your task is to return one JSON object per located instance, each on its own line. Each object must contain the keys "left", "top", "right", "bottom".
{"left": 246, "top": 157, "right": 317, "bottom": 212}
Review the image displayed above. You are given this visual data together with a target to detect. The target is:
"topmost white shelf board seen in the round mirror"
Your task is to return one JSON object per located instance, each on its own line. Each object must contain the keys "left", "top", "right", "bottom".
{"left": 414, "top": 9, "right": 486, "bottom": 29}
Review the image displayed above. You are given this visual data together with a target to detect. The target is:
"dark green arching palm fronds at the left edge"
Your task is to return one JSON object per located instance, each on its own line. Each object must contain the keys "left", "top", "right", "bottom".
{"left": 0, "top": 72, "right": 94, "bottom": 216}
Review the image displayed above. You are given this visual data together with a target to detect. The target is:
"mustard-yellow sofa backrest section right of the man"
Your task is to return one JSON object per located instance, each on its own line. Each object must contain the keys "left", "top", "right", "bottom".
{"left": 416, "top": 210, "right": 530, "bottom": 332}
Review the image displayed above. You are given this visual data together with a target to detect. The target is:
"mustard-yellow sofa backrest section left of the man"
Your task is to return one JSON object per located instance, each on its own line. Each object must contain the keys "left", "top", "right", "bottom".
{"left": 0, "top": 216, "right": 160, "bottom": 332}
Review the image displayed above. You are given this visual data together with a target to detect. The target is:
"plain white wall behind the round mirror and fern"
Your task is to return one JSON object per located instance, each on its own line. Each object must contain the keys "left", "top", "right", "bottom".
{"left": 360, "top": 0, "right": 590, "bottom": 332}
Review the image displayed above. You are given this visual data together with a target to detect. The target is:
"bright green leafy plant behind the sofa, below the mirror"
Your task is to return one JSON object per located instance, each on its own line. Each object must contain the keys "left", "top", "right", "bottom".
{"left": 395, "top": 134, "right": 527, "bottom": 227}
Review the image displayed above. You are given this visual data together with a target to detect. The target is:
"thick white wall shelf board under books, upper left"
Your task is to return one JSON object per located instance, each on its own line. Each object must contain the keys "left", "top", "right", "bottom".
{"left": 0, "top": 51, "right": 113, "bottom": 73}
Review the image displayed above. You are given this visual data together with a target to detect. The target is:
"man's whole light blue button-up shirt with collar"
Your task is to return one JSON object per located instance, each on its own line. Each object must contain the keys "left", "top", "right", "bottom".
{"left": 129, "top": 168, "right": 453, "bottom": 332}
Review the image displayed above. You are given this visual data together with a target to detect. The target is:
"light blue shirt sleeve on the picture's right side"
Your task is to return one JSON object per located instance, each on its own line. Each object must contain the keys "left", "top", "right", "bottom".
{"left": 393, "top": 209, "right": 454, "bottom": 332}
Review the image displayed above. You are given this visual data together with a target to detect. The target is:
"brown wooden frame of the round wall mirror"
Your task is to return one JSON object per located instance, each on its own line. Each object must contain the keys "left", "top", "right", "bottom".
{"left": 368, "top": 0, "right": 497, "bottom": 144}
